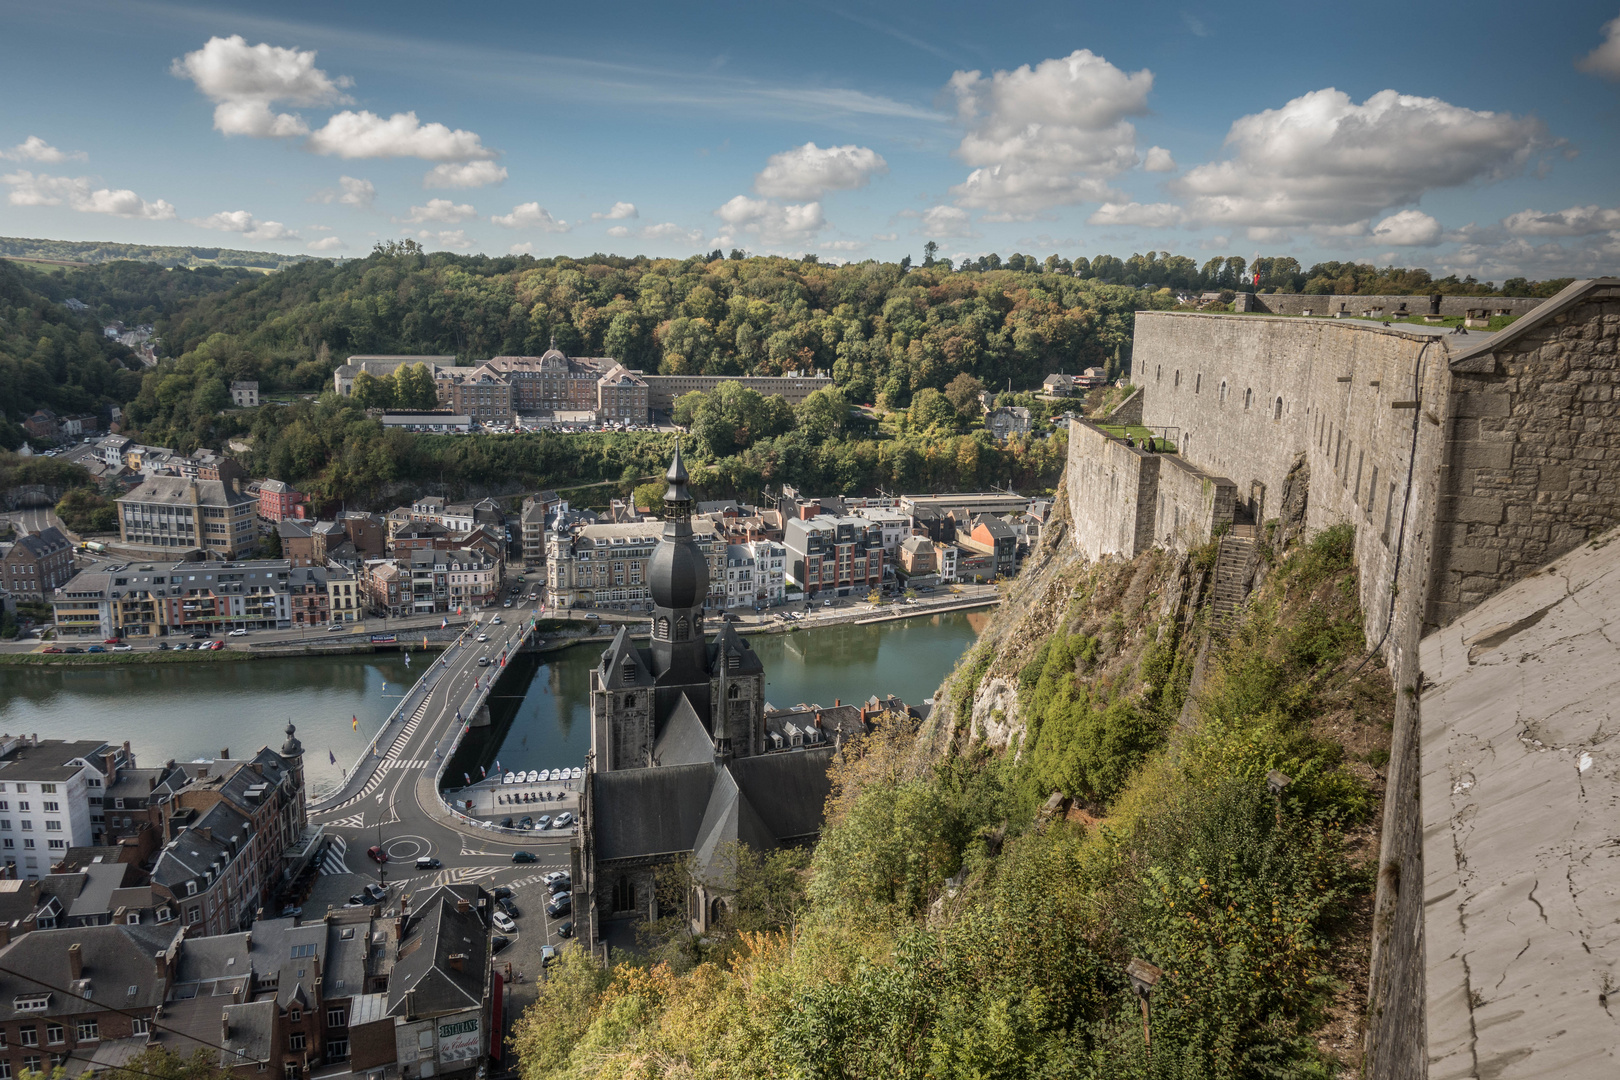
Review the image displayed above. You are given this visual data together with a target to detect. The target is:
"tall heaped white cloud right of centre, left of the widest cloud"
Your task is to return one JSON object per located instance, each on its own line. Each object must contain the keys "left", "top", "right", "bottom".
{"left": 948, "top": 49, "right": 1153, "bottom": 220}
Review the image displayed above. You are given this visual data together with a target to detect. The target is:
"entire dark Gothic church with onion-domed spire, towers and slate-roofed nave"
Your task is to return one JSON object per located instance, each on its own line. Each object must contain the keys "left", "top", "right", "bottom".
{"left": 577, "top": 445, "right": 836, "bottom": 934}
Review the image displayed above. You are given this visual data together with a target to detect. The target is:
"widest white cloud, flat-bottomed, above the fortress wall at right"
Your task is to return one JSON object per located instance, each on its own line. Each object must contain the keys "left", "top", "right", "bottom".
{"left": 1171, "top": 87, "right": 1550, "bottom": 225}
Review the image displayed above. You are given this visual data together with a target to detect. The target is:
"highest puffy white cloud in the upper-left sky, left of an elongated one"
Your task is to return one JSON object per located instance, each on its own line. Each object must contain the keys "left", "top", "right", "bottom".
{"left": 170, "top": 34, "right": 352, "bottom": 138}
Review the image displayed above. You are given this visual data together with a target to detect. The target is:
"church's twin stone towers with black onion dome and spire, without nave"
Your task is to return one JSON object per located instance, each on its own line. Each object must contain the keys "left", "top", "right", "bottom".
{"left": 591, "top": 444, "right": 765, "bottom": 772}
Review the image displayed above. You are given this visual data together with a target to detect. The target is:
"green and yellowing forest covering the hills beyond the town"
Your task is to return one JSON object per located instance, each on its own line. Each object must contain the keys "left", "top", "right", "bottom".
{"left": 0, "top": 241, "right": 1557, "bottom": 502}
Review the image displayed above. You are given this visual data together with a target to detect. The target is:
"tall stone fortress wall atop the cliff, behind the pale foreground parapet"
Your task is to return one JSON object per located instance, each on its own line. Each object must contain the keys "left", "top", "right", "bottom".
{"left": 1068, "top": 279, "right": 1620, "bottom": 1077}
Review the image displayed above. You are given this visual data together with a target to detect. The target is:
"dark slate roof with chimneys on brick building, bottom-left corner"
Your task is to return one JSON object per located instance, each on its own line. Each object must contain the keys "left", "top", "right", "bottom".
{"left": 0, "top": 925, "right": 180, "bottom": 1022}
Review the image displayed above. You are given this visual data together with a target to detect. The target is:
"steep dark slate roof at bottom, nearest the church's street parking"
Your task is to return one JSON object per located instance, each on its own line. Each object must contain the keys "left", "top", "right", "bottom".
{"left": 389, "top": 886, "right": 489, "bottom": 1017}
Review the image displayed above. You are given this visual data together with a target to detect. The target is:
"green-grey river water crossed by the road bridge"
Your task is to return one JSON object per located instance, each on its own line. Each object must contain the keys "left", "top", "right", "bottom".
{"left": 0, "top": 610, "right": 988, "bottom": 793}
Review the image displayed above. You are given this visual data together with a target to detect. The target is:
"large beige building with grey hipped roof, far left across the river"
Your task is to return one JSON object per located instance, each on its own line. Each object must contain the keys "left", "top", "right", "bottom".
{"left": 118, "top": 476, "right": 259, "bottom": 559}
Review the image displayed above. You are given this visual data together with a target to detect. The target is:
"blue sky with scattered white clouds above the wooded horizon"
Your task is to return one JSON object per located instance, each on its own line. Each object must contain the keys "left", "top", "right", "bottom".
{"left": 0, "top": 0, "right": 1620, "bottom": 282}
